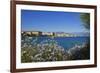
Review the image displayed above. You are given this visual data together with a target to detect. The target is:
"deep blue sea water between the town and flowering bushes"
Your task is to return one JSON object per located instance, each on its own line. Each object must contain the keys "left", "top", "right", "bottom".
{"left": 22, "top": 37, "right": 89, "bottom": 49}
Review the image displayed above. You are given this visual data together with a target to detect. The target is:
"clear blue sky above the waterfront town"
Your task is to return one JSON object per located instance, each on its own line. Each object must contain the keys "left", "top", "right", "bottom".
{"left": 21, "top": 10, "right": 85, "bottom": 32}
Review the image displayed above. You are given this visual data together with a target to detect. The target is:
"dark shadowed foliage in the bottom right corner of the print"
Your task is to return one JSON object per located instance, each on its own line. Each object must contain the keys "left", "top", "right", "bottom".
{"left": 69, "top": 43, "right": 90, "bottom": 60}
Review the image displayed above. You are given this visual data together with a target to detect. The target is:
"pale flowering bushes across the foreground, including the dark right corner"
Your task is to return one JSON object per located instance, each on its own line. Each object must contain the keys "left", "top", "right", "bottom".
{"left": 21, "top": 37, "right": 90, "bottom": 63}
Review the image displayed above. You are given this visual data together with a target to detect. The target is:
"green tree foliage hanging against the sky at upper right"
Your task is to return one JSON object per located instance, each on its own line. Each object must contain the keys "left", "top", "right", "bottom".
{"left": 80, "top": 13, "right": 90, "bottom": 30}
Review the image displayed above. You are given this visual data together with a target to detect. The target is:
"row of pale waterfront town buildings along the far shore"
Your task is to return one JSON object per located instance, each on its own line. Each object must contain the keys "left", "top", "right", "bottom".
{"left": 21, "top": 31, "right": 80, "bottom": 37}
